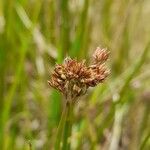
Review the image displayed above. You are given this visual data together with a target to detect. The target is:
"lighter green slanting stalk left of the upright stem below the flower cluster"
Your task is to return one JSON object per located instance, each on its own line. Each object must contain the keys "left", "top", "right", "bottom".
{"left": 55, "top": 101, "right": 69, "bottom": 150}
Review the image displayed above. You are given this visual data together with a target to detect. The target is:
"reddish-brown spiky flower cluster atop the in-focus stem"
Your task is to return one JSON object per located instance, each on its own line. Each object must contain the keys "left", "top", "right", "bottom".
{"left": 48, "top": 47, "right": 110, "bottom": 100}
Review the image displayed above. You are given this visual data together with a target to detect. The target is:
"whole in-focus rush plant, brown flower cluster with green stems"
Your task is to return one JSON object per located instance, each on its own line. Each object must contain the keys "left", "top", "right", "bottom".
{"left": 48, "top": 47, "right": 110, "bottom": 150}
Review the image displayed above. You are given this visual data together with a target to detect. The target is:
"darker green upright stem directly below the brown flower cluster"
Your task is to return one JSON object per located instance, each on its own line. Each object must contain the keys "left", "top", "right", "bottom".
{"left": 62, "top": 103, "right": 73, "bottom": 150}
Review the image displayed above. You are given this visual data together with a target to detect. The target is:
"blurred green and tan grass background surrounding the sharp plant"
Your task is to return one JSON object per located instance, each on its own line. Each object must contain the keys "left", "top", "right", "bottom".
{"left": 0, "top": 0, "right": 150, "bottom": 150}
